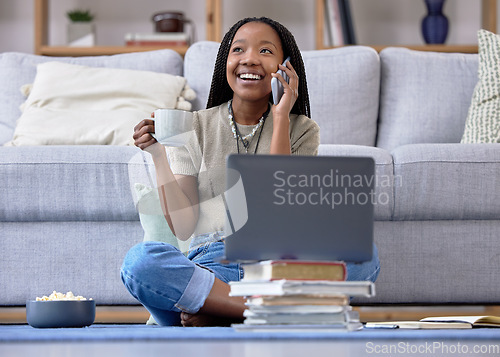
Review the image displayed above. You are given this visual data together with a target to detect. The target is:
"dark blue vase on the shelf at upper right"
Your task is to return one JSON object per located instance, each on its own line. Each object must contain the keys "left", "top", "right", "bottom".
{"left": 422, "top": 0, "right": 448, "bottom": 44}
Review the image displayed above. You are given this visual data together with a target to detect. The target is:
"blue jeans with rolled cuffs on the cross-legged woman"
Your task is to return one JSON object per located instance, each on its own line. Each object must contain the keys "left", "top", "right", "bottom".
{"left": 121, "top": 232, "right": 380, "bottom": 326}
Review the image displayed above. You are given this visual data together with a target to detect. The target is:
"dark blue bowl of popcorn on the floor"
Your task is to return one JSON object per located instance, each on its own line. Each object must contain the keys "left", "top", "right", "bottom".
{"left": 26, "top": 291, "right": 95, "bottom": 328}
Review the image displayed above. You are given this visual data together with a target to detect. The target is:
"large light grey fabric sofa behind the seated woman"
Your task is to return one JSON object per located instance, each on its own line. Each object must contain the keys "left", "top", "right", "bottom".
{"left": 0, "top": 42, "right": 500, "bottom": 306}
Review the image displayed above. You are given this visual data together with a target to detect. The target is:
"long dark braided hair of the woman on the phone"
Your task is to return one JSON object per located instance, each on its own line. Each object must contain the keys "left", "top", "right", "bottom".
{"left": 207, "top": 17, "right": 311, "bottom": 117}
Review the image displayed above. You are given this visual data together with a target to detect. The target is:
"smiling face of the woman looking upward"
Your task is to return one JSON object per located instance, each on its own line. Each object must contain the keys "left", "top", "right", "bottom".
{"left": 226, "top": 22, "right": 283, "bottom": 101}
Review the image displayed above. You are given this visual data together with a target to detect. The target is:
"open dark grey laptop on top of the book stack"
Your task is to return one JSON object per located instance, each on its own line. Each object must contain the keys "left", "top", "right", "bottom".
{"left": 223, "top": 154, "right": 375, "bottom": 262}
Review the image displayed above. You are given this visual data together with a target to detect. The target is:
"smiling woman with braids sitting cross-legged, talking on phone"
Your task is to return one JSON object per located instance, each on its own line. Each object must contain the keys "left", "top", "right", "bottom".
{"left": 121, "top": 18, "right": 378, "bottom": 326}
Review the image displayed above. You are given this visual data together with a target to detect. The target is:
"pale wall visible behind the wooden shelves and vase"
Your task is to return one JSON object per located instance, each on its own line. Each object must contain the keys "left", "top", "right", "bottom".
{"left": 0, "top": 0, "right": 500, "bottom": 53}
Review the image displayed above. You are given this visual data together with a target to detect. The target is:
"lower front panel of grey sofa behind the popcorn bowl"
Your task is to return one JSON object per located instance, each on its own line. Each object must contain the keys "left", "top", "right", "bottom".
{"left": 0, "top": 220, "right": 143, "bottom": 306}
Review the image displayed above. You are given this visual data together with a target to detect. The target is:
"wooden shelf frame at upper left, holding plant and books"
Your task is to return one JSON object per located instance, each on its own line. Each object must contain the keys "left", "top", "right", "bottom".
{"left": 34, "top": 0, "right": 222, "bottom": 57}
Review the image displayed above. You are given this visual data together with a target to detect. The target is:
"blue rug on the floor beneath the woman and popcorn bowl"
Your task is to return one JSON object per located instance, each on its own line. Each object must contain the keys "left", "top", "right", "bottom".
{"left": 0, "top": 324, "right": 500, "bottom": 343}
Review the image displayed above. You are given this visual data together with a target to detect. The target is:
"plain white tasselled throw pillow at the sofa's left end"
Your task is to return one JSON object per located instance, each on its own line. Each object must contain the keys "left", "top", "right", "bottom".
{"left": 6, "top": 62, "right": 192, "bottom": 146}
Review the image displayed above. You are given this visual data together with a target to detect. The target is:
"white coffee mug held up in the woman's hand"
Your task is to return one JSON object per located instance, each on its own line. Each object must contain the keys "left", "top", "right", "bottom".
{"left": 152, "top": 109, "right": 193, "bottom": 146}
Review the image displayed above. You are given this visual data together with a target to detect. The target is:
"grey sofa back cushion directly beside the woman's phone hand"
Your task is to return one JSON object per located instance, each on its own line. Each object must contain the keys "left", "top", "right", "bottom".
{"left": 302, "top": 46, "right": 380, "bottom": 146}
